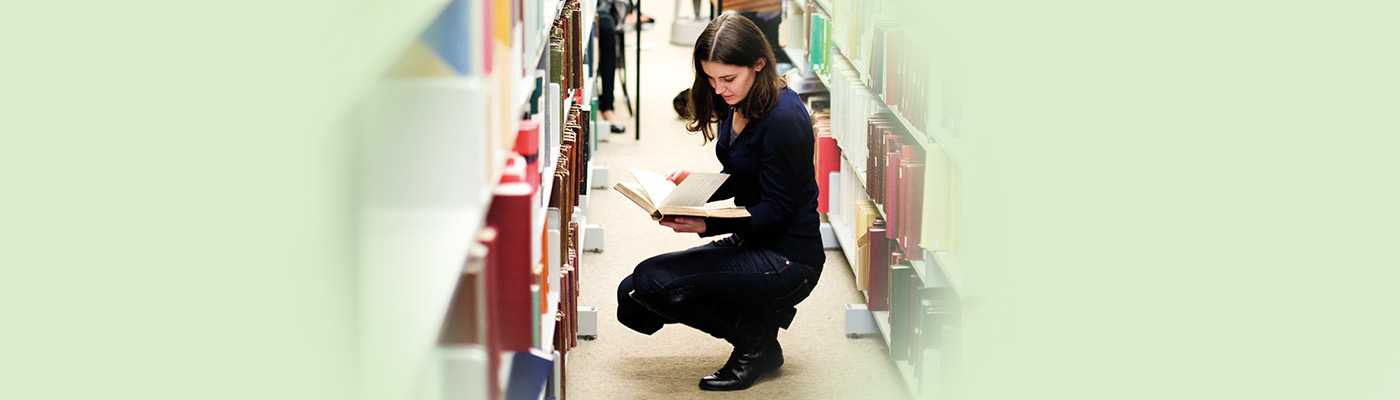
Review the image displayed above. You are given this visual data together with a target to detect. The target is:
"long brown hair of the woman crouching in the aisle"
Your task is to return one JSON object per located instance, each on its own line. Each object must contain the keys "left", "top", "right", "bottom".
{"left": 686, "top": 14, "right": 787, "bottom": 143}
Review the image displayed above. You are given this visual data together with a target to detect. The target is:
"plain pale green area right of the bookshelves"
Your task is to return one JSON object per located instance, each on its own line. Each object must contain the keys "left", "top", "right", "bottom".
{"left": 903, "top": 1, "right": 1400, "bottom": 399}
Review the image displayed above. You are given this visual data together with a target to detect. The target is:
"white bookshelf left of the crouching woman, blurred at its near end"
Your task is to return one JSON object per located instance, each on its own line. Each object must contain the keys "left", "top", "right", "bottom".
{"left": 351, "top": 0, "right": 595, "bottom": 399}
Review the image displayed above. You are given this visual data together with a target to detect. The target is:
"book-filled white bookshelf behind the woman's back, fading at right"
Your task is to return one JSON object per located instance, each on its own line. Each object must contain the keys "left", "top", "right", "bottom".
{"left": 783, "top": 0, "right": 972, "bottom": 399}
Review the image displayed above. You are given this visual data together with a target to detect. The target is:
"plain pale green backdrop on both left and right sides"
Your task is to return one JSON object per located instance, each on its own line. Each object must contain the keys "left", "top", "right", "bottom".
{"left": 0, "top": 1, "right": 1400, "bottom": 399}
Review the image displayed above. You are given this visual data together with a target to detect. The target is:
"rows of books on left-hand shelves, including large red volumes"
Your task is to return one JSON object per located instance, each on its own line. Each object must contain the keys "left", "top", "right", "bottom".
{"left": 436, "top": 0, "right": 594, "bottom": 399}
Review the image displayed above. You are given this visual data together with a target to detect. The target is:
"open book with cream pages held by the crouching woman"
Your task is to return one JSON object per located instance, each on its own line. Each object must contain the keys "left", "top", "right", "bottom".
{"left": 613, "top": 168, "right": 749, "bottom": 221}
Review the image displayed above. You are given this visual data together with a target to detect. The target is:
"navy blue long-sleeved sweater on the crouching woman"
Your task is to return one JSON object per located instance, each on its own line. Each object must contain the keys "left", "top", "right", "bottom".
{"left": 701, "top": 88, "right": 826, "bottom": 269}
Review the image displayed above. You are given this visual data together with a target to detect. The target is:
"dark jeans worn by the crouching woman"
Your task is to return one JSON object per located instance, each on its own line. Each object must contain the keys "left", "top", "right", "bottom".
{"left": 617, "top": 236, "right": 822, "bottom": 343}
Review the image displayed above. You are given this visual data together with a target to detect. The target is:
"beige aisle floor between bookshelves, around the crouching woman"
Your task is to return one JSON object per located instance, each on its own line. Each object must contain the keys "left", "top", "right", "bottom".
{"left": 567, "top": 1, "right": 909, "bottom": 400}
